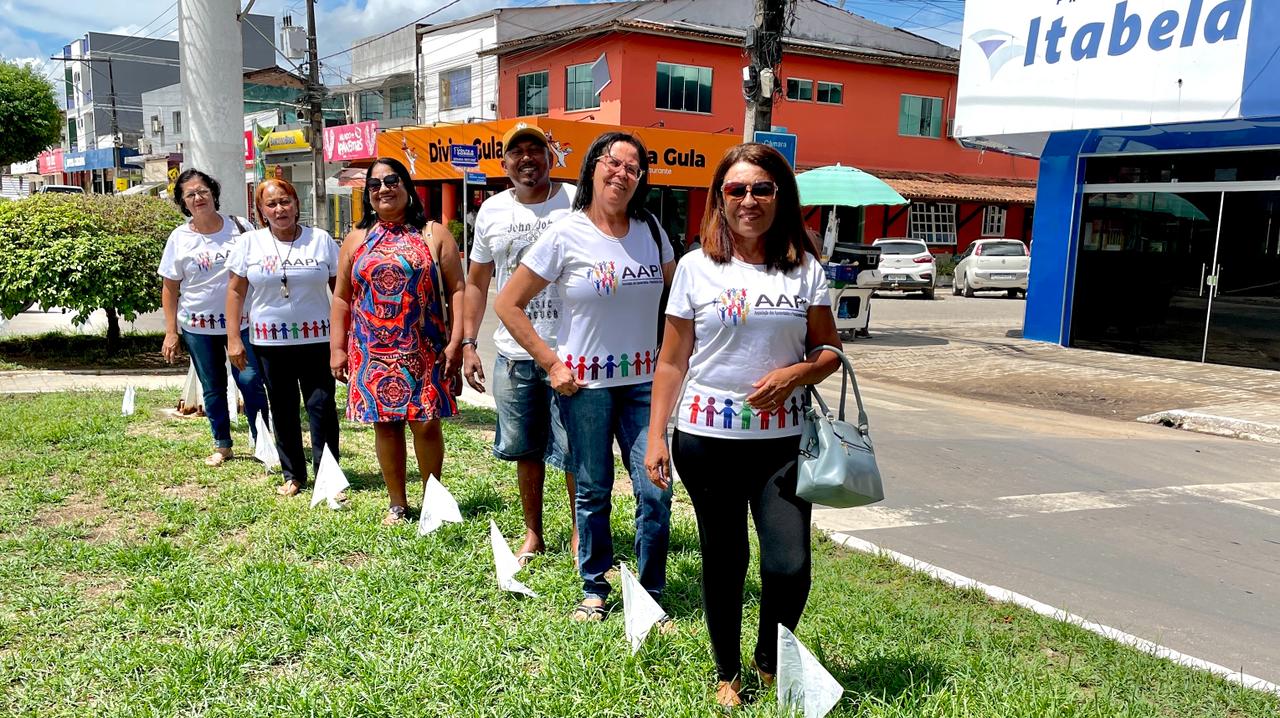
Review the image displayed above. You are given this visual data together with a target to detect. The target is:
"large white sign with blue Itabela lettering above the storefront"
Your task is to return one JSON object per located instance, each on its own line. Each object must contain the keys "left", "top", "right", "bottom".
{"left": 955, "top": 0, "right": 1264, "bottom": 137}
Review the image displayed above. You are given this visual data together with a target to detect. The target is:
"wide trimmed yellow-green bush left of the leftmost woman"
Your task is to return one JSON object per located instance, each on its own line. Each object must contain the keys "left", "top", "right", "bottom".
{"left": 0, "top": 195, "right": 182, "bottom": 349}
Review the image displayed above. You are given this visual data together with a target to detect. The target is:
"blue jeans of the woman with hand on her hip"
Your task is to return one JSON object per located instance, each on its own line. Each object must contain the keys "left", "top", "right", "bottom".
{"left": 559, "top": 383, "right": 671, "bottom": 599}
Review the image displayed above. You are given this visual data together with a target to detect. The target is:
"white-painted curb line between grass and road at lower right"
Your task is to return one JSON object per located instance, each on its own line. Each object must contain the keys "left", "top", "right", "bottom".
{"left": 829, "top": 532, "right": 1280, "bottom": 695}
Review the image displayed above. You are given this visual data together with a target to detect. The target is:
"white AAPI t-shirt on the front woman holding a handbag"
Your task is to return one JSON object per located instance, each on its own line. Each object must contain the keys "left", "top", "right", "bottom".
{"left": 667, "top": 250, "right": 831, "bottom": 439}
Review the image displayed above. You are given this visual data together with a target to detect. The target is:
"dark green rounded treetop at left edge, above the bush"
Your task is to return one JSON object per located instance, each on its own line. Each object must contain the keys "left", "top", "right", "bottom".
{"left": 0, "top": 61, "right": 63, "bottom": 165}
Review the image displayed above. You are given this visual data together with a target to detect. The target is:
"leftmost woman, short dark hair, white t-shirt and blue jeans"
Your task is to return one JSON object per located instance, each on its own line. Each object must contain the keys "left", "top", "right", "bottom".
{"left": 159, "top": 169, "right": 266, "bottom": 466}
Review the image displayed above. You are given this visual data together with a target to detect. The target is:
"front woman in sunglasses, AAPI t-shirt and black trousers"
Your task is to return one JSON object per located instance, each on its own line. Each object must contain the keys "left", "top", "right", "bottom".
{"left": 645, "top": 142, "right": 840, "bottom": 706}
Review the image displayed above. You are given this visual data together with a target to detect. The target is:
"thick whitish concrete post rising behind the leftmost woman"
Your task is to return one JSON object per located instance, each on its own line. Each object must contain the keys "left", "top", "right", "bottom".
{"left": 178, "top": 0, "right": 248, "bottom": 216}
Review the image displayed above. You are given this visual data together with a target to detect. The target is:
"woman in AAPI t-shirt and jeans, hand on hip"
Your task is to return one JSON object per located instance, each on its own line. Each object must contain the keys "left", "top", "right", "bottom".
{"left": 494, "top": 132, "right": 676, "bottom": 627}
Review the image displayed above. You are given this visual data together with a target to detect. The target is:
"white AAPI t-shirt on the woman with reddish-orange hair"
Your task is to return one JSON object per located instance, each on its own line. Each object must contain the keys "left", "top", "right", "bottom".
{"left": 227, "top": 227, "right": 338, "bottom": 346}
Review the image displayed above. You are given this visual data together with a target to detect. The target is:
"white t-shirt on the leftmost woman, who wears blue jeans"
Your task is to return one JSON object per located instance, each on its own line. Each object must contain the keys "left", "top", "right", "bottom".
{"left": 159, "top": 216, "right": 253, "bottom": 334}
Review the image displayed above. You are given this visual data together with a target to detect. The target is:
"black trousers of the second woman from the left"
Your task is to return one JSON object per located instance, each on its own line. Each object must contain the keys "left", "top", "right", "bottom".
{"left": 253, "top": 342, "right": 338, "bottom": 486}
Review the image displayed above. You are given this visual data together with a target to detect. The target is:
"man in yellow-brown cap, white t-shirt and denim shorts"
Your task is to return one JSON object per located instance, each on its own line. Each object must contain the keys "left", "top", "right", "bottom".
{"left": 462, "top": 123, "right": 577, "bottom": 564}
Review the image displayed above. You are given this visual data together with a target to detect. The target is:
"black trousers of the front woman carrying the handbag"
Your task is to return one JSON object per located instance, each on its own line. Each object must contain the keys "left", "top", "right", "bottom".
{"left": 671, "top": 430, "right": 813, "bottom": 681}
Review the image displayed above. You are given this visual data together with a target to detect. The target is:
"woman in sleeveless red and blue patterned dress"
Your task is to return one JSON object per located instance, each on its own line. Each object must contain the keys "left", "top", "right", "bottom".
{"left": 329, "top": 157, "right": 463, "bottom": 525}
